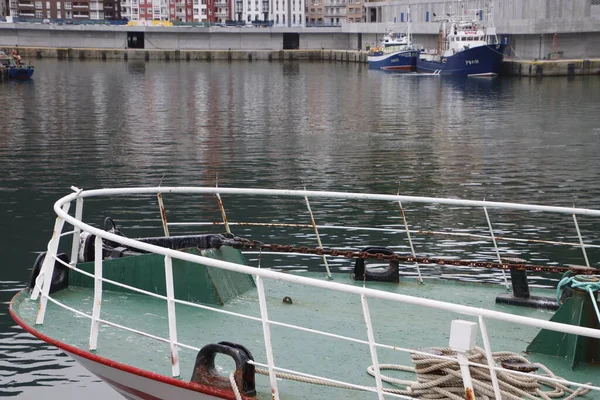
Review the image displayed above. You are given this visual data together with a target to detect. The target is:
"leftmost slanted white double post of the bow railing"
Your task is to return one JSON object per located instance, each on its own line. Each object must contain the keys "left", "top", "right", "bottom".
{"left": 31, "top": 203, "right": 71, "bottom": 325}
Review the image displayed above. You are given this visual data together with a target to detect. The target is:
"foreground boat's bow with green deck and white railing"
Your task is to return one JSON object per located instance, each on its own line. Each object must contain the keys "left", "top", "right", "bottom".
{"left": 9, "top": 187, "right": 600, "bottom": 400}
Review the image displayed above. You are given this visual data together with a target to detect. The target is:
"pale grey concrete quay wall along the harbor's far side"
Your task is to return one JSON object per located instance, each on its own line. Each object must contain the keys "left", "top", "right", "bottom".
{"left": 0, "top": 20, "right": 600, "bottom": 60}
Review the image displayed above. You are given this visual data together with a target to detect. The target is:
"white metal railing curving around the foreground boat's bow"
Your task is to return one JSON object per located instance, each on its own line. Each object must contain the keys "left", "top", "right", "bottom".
{"left": 31, "top": 187, "right": 600, "bottom": 399}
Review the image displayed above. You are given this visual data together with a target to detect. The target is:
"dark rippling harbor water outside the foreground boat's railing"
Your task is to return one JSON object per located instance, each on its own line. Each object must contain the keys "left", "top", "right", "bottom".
{"left": 0, "top": 59, "right": 600, "bottom": 400}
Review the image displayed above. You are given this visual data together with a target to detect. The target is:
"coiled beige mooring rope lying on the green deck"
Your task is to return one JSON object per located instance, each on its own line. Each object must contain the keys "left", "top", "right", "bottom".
{"left": 256, "top": 347, "right": 590, "bottom": 400}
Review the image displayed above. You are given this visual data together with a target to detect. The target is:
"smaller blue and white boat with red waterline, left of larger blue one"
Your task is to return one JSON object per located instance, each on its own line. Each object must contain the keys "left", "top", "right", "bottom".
{"left": 367, "top": 7, "right": 420, "bottom": 71}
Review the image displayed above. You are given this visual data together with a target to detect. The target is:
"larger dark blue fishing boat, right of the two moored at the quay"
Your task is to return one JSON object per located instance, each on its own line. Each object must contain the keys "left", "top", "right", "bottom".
{"left": 417, "top": 6, "right": 504, "bottom": 76}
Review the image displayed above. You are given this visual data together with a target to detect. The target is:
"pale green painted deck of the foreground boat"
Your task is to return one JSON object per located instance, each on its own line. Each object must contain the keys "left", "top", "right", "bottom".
{"left": 15, "top": 272, "right": 600, "bottom": 399}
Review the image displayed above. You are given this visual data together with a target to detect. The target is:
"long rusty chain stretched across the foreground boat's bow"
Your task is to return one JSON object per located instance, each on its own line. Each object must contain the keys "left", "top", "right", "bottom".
{"left": 227, "top": 237, "right": 600, "bottom": 275}
